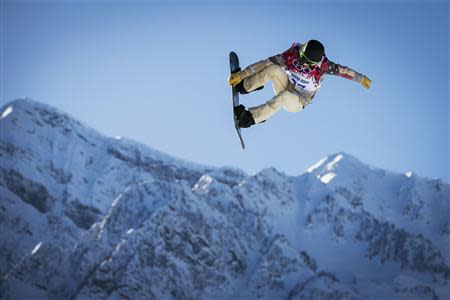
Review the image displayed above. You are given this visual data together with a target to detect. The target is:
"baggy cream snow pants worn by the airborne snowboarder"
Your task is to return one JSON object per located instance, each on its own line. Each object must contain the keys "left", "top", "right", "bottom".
{"left": 243, "top": 60, "right": 305, "bottom": 124}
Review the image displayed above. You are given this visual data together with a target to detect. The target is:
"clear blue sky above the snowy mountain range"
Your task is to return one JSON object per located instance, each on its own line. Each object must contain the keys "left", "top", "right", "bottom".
{"left": 1, "top": 0, "right": 450, "bottom": 182}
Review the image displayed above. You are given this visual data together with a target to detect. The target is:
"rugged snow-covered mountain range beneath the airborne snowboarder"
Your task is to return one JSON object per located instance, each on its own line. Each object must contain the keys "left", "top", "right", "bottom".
{"left": 0, "top": 99, "right": 450, "bottom": 299}
